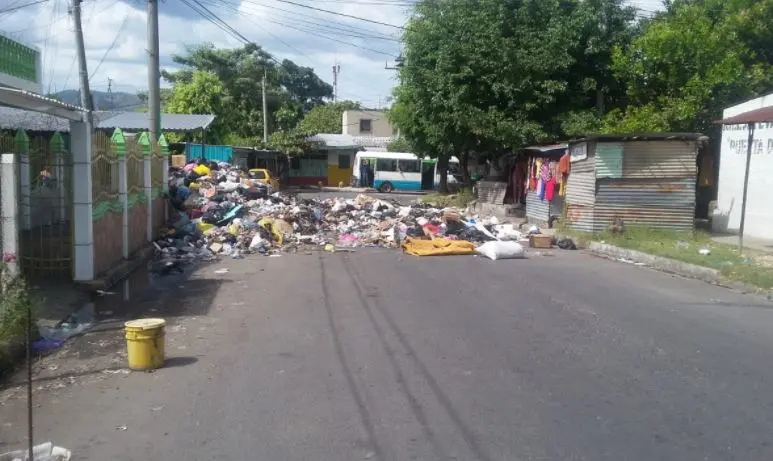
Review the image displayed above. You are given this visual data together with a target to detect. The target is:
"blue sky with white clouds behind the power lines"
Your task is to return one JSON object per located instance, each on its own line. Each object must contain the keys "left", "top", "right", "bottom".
{"left": 0, "top": 0, "right": 661, "bottom": 107}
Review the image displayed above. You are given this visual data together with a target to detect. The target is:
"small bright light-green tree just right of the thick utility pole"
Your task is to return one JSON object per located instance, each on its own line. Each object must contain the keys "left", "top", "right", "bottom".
{"left": 166, "top": 71, "right": 233, "bottom": 141}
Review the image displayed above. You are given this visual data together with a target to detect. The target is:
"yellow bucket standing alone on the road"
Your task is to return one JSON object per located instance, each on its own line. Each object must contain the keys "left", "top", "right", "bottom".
{"left": 124, "top": 319, "right": 166, "bottom": 370}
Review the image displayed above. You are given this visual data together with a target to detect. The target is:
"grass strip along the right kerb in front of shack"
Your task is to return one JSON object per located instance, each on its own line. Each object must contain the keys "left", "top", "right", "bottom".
{"left": 562, "top": 227, "right": 773, "bottom": 290}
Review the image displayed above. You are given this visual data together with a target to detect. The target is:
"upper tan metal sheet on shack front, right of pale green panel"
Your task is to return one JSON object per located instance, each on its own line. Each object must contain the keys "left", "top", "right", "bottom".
{"left": 623, "top": 140, "right": 698, "bottom": 178}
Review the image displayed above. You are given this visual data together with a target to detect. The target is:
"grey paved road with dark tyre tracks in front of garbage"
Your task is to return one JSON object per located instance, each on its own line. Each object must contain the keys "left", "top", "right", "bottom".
{"left": 0, "top": 250, "right": 773, "bottom": 461}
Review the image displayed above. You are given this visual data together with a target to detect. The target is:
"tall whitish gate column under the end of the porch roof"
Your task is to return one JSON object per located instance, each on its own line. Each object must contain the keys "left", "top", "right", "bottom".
{"left": 70, "top": 120, "right": 94, "bottom": 282}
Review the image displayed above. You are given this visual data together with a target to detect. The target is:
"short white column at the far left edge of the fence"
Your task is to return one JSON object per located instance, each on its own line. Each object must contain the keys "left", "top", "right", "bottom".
{"left": 0, "top": 154, "right": 19, "bottom": 275}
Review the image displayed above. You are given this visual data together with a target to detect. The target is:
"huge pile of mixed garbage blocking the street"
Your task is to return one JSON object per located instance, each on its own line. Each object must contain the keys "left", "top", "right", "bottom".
{"left": 155, "top": 162, "right": 524, "bottom": 266}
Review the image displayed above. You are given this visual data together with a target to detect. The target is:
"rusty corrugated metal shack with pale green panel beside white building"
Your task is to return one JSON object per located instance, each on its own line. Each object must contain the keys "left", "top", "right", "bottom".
{"left": 566, "top": 133, "right": 707, "bottom": 232}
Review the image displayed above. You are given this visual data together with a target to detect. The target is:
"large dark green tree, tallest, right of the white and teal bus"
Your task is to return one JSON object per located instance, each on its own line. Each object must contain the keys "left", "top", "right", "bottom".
{"left": 390, "top": 0, "right": 634, "bottom": 189}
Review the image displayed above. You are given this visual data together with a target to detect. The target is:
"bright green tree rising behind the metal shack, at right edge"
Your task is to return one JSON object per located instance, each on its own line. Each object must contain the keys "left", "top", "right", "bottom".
{"left": 603, "top": 0, "right": 773, "bottom": 132}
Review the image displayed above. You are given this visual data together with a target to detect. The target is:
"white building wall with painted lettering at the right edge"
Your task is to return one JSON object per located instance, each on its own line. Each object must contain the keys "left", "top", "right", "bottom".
{"left": 712, "top": 94, "right": 773, "bottom": 238}
